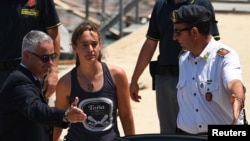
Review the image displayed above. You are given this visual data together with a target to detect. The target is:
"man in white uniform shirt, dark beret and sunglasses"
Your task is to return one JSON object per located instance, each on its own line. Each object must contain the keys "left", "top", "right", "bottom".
{"left": 171, "top": 5, "right": 245, "bottom": 134}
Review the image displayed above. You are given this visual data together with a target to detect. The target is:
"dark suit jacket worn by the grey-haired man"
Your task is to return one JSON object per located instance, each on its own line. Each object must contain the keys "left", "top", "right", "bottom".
{"left": 0, "top": 65, "right": 68, "bottom": 141}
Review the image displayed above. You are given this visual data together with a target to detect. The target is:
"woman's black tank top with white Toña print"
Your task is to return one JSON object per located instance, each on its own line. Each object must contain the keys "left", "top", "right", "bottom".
{"left": 66, "top": 62, "right": 120, "bottom": 141}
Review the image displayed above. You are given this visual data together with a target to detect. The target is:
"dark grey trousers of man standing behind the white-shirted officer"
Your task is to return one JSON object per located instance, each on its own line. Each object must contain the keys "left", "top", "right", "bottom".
{"left": 155, "top": 74, "right": 179, "bottom": 134}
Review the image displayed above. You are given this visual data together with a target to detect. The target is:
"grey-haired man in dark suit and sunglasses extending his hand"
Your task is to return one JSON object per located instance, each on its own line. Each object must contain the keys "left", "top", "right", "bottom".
{"left": 0, "top": 30, "right": 86, "bottom": 141}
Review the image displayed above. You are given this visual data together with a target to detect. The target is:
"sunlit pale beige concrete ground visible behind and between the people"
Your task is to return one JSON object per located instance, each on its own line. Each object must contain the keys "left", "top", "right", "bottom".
{"left": 52, "top": 13, "right": 250, "bottom": 139}
